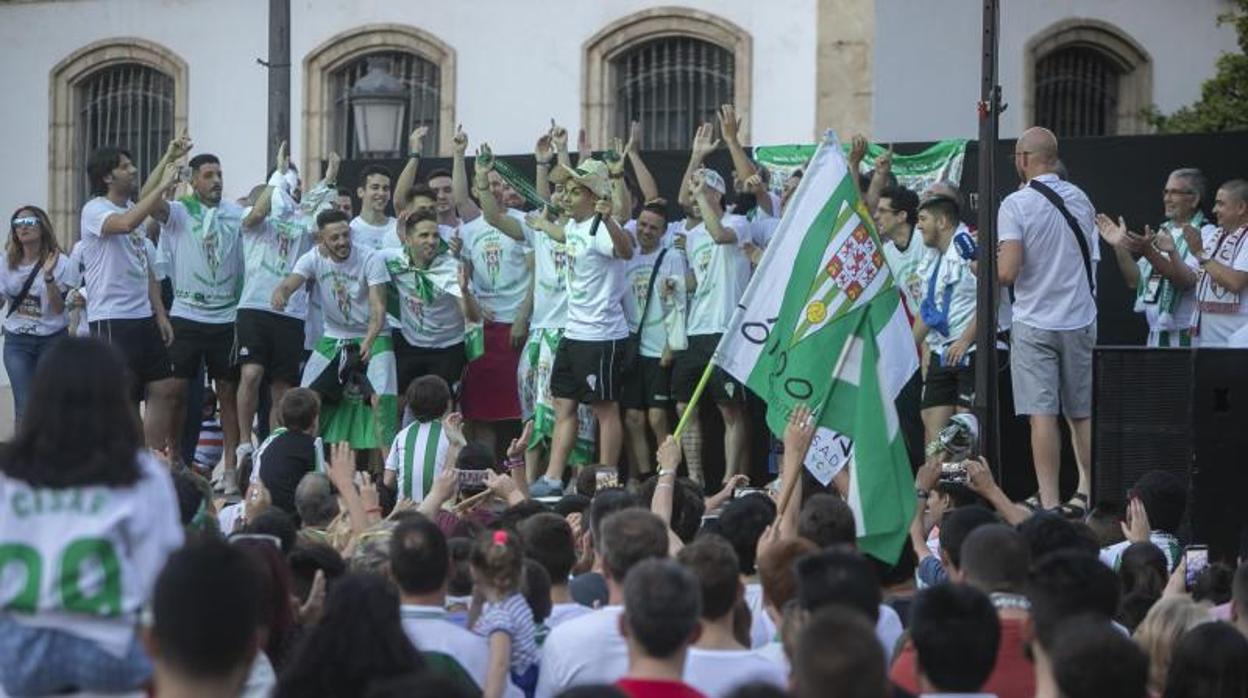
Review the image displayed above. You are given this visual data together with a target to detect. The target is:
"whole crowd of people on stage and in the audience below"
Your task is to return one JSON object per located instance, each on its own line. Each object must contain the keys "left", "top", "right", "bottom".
{"left": 0, "top": 106, "right": 1248, "bottom": 698}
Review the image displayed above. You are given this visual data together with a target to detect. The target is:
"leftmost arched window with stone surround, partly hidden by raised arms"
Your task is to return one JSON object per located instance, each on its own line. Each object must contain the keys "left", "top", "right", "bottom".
{"left": 47, "top": 37, "right": 188, "bottom": 247}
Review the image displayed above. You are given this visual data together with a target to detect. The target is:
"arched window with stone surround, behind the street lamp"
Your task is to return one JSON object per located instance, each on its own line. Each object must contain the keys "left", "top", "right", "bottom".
{"left": 300, "top": 24, "right": 456, "bottom": 184}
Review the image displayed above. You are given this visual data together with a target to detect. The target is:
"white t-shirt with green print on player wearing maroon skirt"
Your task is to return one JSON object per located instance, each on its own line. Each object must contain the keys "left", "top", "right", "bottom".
{"left": 459, "top": 209, "right": 529, "bottom": 325}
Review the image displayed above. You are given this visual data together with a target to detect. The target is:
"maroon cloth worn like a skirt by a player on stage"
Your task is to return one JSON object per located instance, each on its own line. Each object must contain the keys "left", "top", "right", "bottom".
{"left": 459, "top": 322, "right": 520, "bottom": 422}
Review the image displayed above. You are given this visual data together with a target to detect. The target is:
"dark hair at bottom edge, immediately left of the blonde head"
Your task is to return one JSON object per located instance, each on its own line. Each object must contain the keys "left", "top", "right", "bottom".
{"left": 1051, "top": 616, "right": 1148, "bottom": 698}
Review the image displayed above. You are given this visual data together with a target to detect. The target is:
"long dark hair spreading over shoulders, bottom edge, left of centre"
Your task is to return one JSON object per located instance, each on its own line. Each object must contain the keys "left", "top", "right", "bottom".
{"left": 277, "top": 573, "right": 424, "bottom": 697}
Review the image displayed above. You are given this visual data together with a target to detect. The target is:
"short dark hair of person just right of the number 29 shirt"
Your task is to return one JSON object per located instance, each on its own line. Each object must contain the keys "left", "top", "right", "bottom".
{"left": 152, "top": 539, "right": 262, "bottom": 678}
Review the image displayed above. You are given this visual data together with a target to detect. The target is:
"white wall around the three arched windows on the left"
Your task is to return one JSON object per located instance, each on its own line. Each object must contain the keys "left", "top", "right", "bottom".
{"left": 0, "top": 0, "right": 815, "bottom": 218}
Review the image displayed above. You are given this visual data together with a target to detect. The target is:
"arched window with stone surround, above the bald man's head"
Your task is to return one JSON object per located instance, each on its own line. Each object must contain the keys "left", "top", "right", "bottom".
{"left": 1026, "top": 20, "right": 1152, "bottom": 137}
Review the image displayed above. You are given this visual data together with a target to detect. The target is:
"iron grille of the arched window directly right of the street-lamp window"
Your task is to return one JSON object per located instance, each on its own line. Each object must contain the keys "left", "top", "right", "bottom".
{"left": 612, "top": 36, "right": 735, "bottom": 150}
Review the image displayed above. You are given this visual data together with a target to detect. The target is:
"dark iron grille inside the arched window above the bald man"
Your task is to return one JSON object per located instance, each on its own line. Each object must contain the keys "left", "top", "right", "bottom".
{"left": 1035, "top": 46, "right": 1122, "bottom": 137}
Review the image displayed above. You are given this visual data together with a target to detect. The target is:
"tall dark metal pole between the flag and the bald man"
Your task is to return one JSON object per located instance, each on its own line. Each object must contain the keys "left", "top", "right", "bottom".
{"left": 975, "top": 0, "right": 1002, "bottom": 474}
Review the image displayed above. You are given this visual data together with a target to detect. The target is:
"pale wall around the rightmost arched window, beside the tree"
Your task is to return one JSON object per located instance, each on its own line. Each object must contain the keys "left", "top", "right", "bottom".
{"left": 871, "top": 0, "right": 1238, "bottom": 141}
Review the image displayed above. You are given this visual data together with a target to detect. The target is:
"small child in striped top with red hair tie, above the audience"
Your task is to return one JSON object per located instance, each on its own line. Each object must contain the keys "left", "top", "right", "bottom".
{"left": 470, "top": 531, "right": 538, "bottom": 698}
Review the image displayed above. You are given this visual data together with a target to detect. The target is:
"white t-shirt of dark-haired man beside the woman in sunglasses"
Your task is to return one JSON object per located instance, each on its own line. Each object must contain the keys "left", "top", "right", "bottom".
{"left": 80, "top": 196, "right": 152, "bottom": 322}
